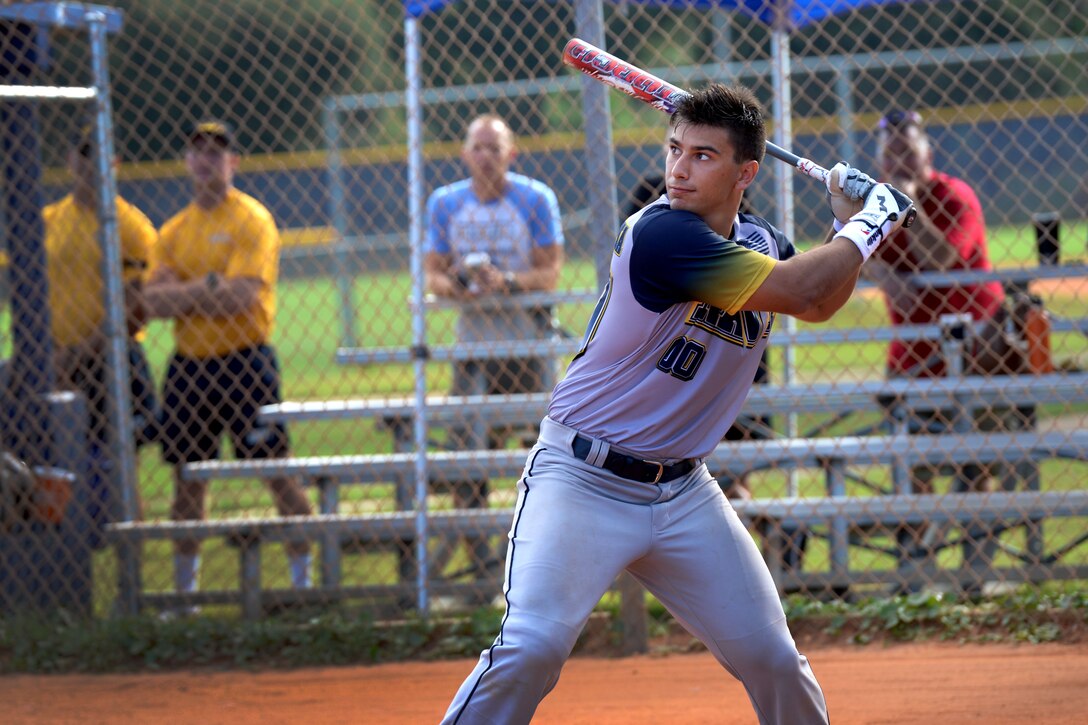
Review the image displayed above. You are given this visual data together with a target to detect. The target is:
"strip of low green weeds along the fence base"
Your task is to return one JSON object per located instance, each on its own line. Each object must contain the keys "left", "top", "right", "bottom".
{"left": 0, "top": 585, "right": 1088, "bottom": 674}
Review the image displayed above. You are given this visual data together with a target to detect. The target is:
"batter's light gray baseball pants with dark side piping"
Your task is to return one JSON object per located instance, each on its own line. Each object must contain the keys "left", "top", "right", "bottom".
{"left": 443, "top": 418, "right": 827, "bottom": 725}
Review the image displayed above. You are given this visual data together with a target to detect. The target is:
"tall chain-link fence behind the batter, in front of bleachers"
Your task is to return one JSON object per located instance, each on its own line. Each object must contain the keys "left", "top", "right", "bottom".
{"left": 0, "top": 0, "right": 1088, "bottom": 631}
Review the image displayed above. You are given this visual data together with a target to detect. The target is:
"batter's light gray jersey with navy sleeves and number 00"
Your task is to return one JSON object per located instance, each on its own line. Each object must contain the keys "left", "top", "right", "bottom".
{"left": 548, "top": 197, "right": 793, "bottom": 460}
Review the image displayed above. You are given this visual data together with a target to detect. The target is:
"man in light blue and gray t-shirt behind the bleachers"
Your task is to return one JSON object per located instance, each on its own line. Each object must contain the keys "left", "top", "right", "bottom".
{"left": 424, "top": 114, "right": 564, "bottom": 587}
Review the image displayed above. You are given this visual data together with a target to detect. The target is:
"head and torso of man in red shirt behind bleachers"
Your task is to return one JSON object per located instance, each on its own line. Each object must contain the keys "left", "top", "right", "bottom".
{"left": 867, "top": 111, "right": 1004, "bottom": 377}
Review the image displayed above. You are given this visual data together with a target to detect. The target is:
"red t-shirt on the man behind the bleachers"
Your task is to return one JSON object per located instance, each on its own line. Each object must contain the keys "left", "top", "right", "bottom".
{"left": 876, "top": 167, "right": 1004, "bottom": 377}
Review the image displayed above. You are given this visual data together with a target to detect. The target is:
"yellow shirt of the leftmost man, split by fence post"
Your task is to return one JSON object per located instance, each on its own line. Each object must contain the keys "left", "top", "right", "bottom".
{"left": 41, "top": 195, "right": 157, "bottom": 346}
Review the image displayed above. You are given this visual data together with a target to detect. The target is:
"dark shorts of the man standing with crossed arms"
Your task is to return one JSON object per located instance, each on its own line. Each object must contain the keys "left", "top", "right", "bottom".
{"left": 161, "top": 345, "right": 289, "bottom": 464}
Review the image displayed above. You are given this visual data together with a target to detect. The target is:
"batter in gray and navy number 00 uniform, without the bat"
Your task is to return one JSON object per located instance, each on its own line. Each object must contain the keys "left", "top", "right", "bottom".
{"left": 444, "top": 85, "right": 910, "bottom": 725}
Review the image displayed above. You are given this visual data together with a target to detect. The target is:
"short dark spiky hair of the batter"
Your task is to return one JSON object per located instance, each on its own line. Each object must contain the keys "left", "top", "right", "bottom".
{"left": 670, "top": 83, "right": 767, "bottom": 163}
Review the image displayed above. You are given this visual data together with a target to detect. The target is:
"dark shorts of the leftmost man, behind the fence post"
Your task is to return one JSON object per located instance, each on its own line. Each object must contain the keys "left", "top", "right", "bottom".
{"left": 71, "top": 341, "right": 160, "bottom": 447}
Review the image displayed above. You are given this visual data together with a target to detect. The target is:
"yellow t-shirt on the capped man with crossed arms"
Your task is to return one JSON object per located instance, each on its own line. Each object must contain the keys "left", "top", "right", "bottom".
{"left": 152, "top": 189, "right": 281, "bottom": 358}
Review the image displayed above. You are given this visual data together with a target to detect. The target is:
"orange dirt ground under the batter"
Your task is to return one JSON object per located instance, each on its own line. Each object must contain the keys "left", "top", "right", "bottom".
{"left": 0, "top": 643, "right": 1088, "bottom": 725}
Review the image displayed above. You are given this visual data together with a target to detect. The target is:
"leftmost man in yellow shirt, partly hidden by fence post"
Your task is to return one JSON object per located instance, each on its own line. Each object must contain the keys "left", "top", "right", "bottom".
{"left": 42, "top": 126, "right": 158, "bottom": 545}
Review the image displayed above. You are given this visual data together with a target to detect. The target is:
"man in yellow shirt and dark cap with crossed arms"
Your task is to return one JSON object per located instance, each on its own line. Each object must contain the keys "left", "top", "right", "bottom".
{"left": 147, "top": 121, "right": 312, "bottom": 592}
